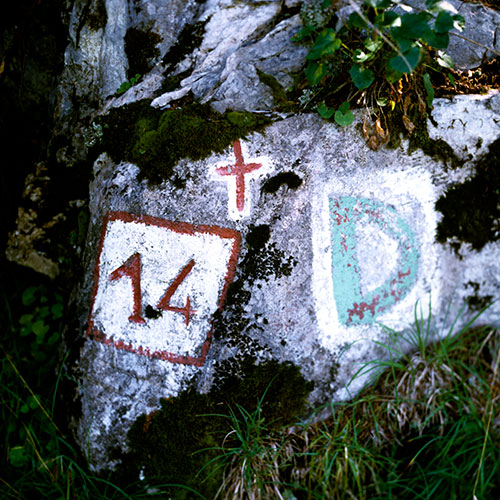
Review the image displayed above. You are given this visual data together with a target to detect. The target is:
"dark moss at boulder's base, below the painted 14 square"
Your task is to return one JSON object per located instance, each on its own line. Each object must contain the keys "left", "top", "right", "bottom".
{"left": 124, "top": 361, "right": 311, "bottom": 499}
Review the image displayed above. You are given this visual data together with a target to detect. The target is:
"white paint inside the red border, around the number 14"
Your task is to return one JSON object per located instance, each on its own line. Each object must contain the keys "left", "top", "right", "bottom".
{"left": 91, "top": 215, "right": 238, "bottom": 356}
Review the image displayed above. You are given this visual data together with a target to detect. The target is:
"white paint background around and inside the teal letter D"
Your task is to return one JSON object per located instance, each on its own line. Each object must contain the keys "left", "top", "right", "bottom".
{"left": 311, "top": 167, "right": 441, "bottom": 352}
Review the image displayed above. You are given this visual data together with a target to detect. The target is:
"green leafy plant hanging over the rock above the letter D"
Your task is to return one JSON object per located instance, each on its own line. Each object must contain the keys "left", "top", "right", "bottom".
{"left": 294, "top": 0, "right": 465, "bottom": 141}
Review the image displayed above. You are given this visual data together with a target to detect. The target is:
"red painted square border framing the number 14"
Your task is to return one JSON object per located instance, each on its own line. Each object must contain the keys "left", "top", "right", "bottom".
{"left": 86, "top": 212, "right": 241, "bottom": 366}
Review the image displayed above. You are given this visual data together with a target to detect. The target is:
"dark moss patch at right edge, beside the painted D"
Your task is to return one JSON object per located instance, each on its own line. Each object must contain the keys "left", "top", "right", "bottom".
{"left": 436, "top": 139, "right": 500, "bottom": 253}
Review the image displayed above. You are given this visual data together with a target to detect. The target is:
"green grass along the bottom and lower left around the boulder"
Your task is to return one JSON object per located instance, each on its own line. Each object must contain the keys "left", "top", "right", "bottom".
{"left": 0, "top": 272, "right": 500, "bottom": 500}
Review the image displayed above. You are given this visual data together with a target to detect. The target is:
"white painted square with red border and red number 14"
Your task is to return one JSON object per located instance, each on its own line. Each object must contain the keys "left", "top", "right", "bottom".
{"left": 87, "top": 212, "right": 241, "bottom": 366}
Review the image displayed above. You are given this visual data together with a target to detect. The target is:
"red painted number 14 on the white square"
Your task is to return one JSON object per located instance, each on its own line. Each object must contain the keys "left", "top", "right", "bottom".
{"left": 109, "top": 252, "right": 196, "bottom": 326}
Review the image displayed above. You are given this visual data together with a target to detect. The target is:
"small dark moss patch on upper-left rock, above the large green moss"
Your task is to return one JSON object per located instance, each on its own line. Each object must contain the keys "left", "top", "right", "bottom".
{"left": 125, "top": 28, "right": 162, "bottom": 79}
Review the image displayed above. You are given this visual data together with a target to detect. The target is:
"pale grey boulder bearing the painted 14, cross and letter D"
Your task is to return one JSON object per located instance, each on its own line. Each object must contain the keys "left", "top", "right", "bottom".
{"left": 73, "top": 94, "right": 500, "bottom": 470}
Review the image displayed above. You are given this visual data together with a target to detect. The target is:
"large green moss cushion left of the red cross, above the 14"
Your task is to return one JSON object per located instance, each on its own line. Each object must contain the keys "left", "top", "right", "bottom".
{"left": 101, "top": 100, "right": 270, "bottom": 183}
